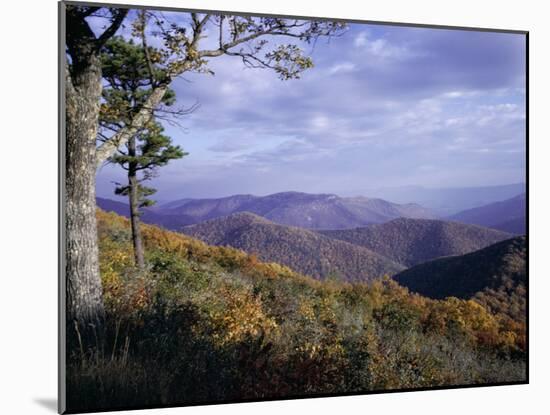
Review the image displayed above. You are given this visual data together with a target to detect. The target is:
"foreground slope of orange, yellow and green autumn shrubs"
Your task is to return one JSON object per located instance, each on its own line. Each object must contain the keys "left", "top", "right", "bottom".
{"left": 68, "top": 211, "right": 526, "bottom": 409}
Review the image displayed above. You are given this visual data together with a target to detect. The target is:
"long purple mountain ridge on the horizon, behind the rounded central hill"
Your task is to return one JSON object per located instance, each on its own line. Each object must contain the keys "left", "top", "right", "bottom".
{"left": 98, "top": 192, "right": 435, "bottom": 230}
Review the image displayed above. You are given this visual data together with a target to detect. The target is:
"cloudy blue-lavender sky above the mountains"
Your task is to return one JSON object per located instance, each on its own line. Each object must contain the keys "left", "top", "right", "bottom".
{"left": 97, "top": 10, "right": 526, "bottom": 201}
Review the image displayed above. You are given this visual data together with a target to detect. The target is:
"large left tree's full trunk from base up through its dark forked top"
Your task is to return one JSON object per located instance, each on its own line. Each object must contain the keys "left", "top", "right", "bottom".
{"left": 65, "top": 5, "right": 128, "bottom": 326}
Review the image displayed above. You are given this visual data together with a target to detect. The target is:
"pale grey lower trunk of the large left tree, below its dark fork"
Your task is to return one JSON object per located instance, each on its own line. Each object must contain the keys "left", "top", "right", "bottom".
{"left": 65, "top": 56, "right": 104, "bottom": 328}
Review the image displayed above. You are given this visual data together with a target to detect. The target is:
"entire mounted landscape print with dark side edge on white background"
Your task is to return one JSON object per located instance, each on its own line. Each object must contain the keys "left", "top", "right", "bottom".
{"left": 59, "top": 2, "right": 528, "bottom": 413}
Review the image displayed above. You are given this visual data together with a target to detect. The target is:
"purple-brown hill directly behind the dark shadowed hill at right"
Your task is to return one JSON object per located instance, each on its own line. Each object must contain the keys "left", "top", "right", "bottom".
{"left": 320, "top": 218, "right": 512, "bottom": 267}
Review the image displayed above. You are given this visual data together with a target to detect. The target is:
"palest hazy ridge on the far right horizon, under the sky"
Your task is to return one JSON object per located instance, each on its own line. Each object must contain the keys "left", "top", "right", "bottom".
{"left": 363, "top": 183, "right": 526, "bottom": 217}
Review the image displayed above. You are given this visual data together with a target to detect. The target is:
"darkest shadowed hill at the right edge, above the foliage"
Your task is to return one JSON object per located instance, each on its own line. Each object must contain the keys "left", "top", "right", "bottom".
{"left": 393, "top": 236, "right": 527, "bottom": 319}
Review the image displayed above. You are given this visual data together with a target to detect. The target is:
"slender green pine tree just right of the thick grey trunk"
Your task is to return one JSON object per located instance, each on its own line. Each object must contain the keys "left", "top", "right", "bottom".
{"left": 100, "top": 37, "right": 187, "bottom": 269}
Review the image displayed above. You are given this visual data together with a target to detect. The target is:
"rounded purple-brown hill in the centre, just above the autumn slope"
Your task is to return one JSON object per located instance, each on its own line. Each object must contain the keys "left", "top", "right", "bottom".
{"left": 182, "top": 212, "right": 404, "bottom": 281}
